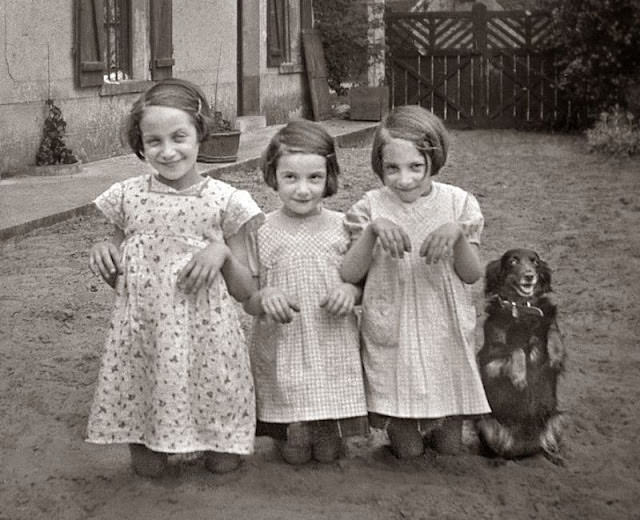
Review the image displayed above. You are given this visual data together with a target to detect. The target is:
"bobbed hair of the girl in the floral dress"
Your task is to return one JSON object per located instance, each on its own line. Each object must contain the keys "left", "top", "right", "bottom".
{"left": 125, "top": 78, "right": 212, "bottom": 160}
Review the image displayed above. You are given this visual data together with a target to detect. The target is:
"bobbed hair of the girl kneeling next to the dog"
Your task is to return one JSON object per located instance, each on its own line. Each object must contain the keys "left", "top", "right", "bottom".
{"left": 371, "top": 105, "right": 449, "bottom": 179}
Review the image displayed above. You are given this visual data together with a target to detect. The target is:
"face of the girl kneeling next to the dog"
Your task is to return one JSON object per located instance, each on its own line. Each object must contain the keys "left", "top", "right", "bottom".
{"left": 382, "top": 138, "right": 431, "bottom": 202}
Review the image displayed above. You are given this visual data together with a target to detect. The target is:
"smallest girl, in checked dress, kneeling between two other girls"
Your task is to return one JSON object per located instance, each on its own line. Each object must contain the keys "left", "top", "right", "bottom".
{"left": 245, "top": 121, "right": 367, "bottom": 464}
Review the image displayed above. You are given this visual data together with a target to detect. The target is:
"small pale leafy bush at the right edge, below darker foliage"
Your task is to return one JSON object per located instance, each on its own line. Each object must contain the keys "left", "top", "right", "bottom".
{"left": 587, "top": 105, "right": 640, "bottom": 155}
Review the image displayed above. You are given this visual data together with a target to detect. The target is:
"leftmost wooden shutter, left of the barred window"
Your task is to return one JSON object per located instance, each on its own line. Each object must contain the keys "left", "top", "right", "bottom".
{"left": 75, "top": 0, "right": 106, "bottom": 87}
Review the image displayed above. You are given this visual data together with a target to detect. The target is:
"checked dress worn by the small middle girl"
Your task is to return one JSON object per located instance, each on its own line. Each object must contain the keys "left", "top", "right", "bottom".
{"left": 250, "top": 209, "right": 367, "bottom": 430}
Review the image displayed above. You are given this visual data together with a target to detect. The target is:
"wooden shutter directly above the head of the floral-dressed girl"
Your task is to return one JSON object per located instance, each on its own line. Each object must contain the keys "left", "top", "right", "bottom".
{"left": 150, "top": 0, "right": 174, "bottom": 80}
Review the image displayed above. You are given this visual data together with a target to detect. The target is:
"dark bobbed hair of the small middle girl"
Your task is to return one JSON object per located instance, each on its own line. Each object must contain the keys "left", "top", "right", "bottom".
{"left": 261, "top": 119, "right": 340, "bottom": 197}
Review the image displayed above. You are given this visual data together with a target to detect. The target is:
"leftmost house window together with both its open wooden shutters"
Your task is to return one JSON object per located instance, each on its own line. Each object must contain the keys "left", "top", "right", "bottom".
{"left": 74, "top": 0, "right": 174, "bottom": 88}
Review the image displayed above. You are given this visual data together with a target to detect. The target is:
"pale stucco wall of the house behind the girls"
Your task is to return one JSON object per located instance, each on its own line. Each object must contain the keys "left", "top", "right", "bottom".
{"left": 0, "top": 0, "right": 306, "bottom": 173}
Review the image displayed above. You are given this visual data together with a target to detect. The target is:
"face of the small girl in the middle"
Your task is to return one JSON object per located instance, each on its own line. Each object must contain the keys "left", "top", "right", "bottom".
{"left": 276, "top": 153, "right": 327, "bottom": 217}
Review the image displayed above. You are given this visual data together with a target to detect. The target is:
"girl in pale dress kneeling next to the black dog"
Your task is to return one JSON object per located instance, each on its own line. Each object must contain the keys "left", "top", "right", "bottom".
{"left": 341, "top": 106, "right": 490, "bottom": 458}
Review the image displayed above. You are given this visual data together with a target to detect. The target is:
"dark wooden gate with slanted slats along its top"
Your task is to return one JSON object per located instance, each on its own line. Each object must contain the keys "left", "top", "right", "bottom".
{"left": 385, "top": 3, "right": 571, "bottom": 128}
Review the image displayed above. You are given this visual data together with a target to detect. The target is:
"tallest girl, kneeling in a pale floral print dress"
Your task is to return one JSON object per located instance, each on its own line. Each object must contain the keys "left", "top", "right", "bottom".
{"left": 87, "top": 79, "right": 263, "bottom": 476}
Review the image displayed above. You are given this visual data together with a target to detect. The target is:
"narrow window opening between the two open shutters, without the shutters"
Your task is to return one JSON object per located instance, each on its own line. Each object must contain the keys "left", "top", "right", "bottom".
{"left": 104, "top": 0, "right": 131, "bottom": 81}
